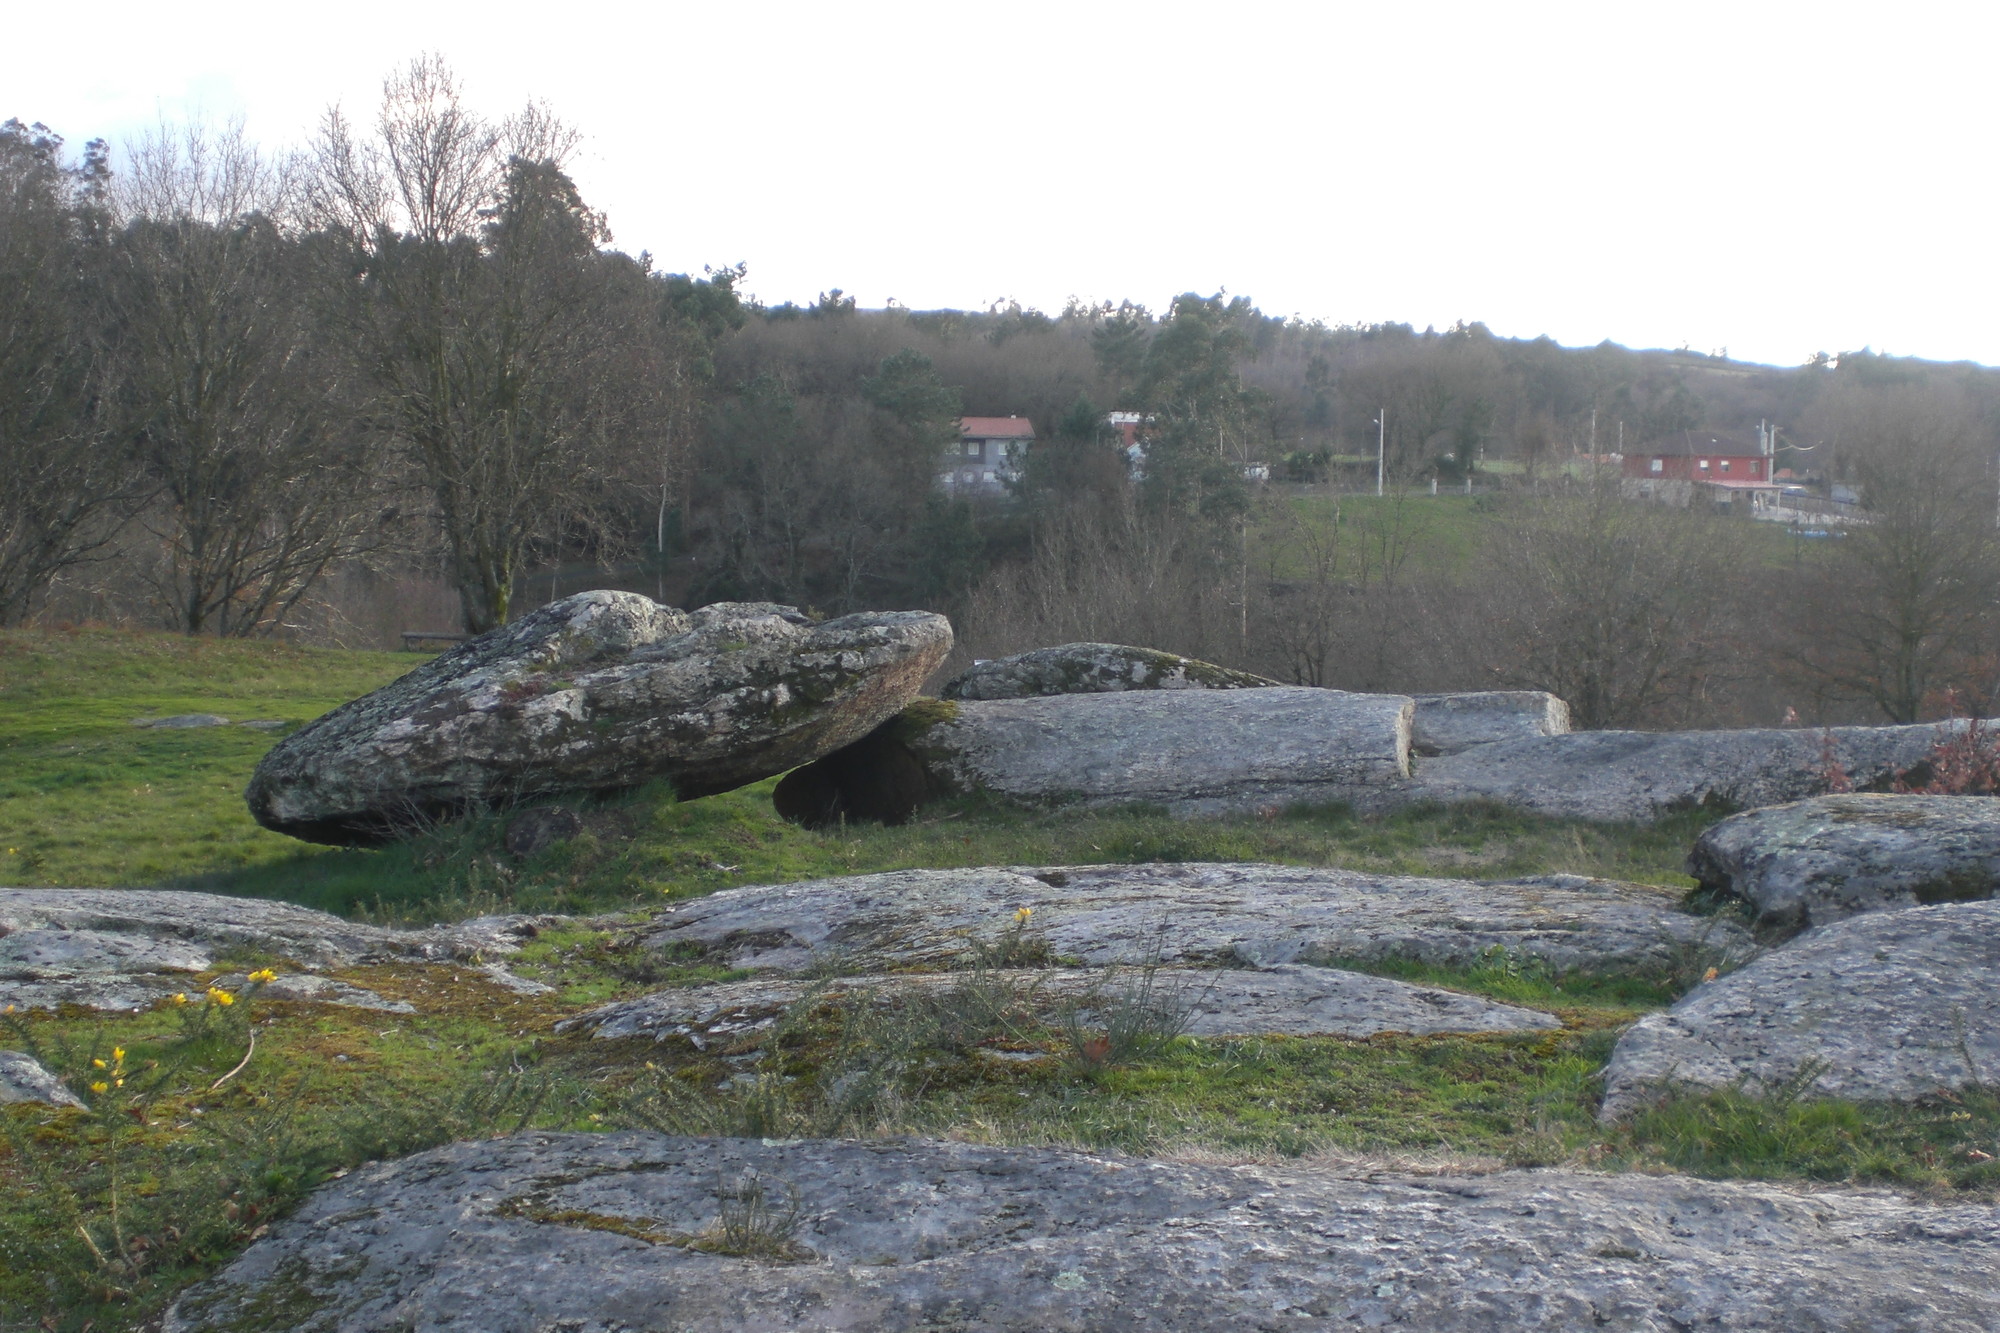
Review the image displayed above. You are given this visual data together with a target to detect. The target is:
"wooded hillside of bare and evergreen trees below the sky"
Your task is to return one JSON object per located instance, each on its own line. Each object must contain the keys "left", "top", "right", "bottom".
{"left": 0, "top": 58, "right": 2000, "bottom": 727}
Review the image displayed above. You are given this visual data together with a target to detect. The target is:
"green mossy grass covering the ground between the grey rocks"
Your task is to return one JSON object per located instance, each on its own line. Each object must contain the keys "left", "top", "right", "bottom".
{"left": 0, "top": 630, "right": 2000, "bottom": 1331}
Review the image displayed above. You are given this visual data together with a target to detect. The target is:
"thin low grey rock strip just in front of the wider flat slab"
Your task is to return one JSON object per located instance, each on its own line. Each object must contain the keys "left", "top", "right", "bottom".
{"left": 558, "top": 965, "right": 1562, "bottom": 1039}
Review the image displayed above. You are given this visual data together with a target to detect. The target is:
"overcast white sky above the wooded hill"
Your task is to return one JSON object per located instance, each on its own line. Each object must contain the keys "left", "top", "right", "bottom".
{"left": 15, "top": 0, "right": 2000, "bottom": 364}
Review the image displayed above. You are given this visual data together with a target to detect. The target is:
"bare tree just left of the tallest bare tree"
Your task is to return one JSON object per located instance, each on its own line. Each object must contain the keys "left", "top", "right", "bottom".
{"left": 108, "top": 124, "right": 380, "bottom": 634}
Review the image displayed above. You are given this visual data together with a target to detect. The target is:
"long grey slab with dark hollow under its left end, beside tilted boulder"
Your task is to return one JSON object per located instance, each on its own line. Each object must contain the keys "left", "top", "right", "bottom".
{"left": 778, "top": 685, "right": 1414, "bottom": 823}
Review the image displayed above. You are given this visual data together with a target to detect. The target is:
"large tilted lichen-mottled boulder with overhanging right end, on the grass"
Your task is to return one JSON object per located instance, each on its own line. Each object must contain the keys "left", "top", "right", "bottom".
{"left": 246, "top": 592, "right": 952, "bottom": 843}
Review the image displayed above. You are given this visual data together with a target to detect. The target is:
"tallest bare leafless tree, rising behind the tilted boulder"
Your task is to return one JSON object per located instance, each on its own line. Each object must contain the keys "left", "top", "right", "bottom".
{"left": 308, "top": 56, "right": 658, "bottom": 632}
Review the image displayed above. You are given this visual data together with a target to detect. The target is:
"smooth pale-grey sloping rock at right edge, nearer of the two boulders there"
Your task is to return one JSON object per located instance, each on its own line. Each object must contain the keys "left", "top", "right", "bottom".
{"left": 1602, "top": 903, "right": 2000, "bottom": 1119}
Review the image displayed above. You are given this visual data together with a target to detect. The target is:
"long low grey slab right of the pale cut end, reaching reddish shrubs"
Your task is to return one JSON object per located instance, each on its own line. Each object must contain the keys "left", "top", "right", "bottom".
{"left": 1400, "top": 723, "right": 1976, "bottom": 821}
